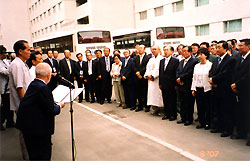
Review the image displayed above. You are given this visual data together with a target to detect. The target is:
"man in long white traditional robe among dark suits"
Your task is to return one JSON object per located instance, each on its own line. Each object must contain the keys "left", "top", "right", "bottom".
{"left": 144, "top": 45, "right": 164, "bottom": 115}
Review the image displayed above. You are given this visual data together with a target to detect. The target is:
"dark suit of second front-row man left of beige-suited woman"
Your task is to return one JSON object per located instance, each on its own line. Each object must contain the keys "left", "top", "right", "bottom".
{"left": 83, "top": 60, "right": 99, "bottom": 102}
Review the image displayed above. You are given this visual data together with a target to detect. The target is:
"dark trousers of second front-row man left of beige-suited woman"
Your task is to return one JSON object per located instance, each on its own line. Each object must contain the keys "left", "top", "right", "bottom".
{"left": 85, "top": 75, "right": 95, "bottom": 101}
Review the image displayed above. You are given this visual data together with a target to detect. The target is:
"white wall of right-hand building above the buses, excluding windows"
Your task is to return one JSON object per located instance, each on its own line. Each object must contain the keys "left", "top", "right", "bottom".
{"left": 135, "top": 0, "right": 250, "bottom": 42}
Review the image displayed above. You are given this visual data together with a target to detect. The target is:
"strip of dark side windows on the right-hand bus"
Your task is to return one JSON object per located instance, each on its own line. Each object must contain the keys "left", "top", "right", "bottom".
{"left": 113, "top": 31, "right": 151, "bottom": 49}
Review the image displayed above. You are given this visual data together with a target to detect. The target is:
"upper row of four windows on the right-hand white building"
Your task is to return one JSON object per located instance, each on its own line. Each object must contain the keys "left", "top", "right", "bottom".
{"left": 139, "top": 0, "right": 209, "bottom": 20}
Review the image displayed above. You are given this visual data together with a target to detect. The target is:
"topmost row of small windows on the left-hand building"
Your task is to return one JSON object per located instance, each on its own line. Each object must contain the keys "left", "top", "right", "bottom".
{"left": 30, "top": 2, "right": 62, "bottom": 25}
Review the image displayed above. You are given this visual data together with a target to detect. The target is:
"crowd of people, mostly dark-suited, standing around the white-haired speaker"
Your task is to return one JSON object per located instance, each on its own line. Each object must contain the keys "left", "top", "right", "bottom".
{"left": 0, "top": 39, "right": 250, "bottom": 160}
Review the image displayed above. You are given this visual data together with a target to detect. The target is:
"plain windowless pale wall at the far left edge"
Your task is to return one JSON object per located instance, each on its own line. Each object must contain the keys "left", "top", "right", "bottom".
{"left": 0, "top": 0, "right": 31, "bottom": 51}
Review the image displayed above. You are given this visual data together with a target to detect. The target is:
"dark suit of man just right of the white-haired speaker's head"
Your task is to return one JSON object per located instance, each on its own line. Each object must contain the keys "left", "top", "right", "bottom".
{"left": 44, "top": 58, "right": 59, "bottom": 91}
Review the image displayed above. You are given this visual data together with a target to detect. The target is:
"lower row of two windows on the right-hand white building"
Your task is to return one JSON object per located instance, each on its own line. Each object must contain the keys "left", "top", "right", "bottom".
{"left": 195, "top": 19, "right": 242, "bottom": 36}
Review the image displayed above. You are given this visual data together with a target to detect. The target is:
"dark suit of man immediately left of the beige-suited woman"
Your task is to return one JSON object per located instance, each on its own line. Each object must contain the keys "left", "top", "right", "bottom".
{"left": 100, "top": 56, "right": 114, "bottom": 102}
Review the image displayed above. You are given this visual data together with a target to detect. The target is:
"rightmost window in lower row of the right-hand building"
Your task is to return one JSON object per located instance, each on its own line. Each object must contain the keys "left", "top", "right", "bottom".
{"left": 224, "top": 19, "right": 242, "bottom": 33}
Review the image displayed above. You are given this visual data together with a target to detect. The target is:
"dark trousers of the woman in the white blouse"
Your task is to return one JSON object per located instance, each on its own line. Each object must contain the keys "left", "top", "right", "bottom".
{"left": 195, "top": 88, "right": 211, "bottom": 126}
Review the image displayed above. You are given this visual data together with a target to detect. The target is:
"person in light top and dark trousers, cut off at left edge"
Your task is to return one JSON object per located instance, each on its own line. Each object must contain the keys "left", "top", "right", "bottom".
{"left": 0, "top": 46, "right": 15, "bottom": 131}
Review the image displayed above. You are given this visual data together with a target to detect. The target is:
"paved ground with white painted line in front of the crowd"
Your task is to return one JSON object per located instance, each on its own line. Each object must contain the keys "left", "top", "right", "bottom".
{"left": 0, "top": 100, "right": 250, "bottom": 161}
